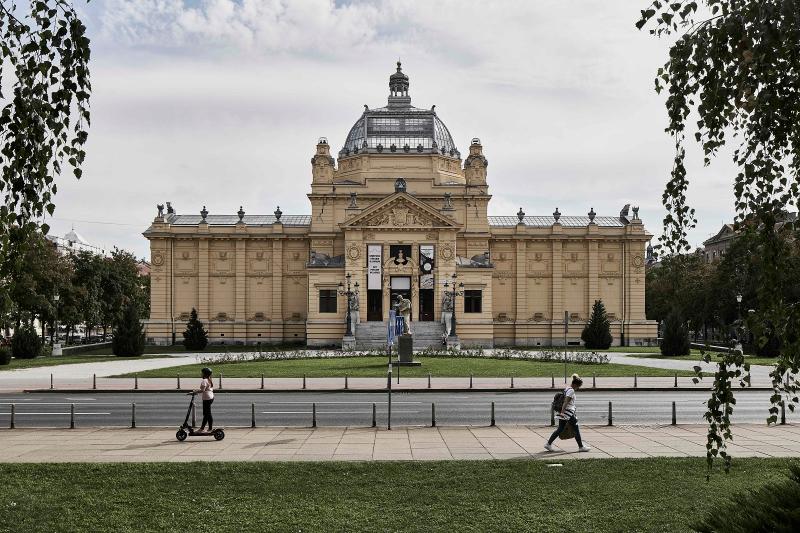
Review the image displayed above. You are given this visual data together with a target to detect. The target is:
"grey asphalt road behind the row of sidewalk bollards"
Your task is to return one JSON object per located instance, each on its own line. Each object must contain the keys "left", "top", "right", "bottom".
{"left": 0, "top": 391, "right": 800, "bottom": 428}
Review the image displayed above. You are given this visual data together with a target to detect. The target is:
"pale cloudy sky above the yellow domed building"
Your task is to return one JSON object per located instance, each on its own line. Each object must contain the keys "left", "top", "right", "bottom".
{"left": 39, "top": 0, "right": 734, "bottom": 257}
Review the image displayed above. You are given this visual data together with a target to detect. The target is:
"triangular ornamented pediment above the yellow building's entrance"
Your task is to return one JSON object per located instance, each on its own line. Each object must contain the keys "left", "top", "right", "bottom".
{"left": 341, "top": 192, "right": 460, "bottom": 229}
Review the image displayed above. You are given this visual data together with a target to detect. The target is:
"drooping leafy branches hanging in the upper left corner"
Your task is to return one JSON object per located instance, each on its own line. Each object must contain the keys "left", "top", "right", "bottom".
{"left": 0, "top": 0, "right": 91, "bottom": 312}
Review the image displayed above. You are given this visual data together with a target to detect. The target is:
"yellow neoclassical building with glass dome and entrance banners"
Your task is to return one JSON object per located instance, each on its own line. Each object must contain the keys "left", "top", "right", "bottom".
{"left": 144, "top": 63, "right": 656, "bottom": 347}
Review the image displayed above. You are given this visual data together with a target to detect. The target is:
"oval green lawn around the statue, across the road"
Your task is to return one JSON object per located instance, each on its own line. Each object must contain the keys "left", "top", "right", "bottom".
{"left": 119, "top": 356, "right": 694, "bottom": 378}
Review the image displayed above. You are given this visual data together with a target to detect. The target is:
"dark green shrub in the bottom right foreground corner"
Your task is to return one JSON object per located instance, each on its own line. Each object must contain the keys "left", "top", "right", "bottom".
{"left": 692, "top": 463, "right": 800, "bottom": 533}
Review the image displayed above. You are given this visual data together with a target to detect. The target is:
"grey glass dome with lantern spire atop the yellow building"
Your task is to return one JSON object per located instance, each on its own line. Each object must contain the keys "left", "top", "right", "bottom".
{"left": 339, "top": 61, "right": 461, "bottom": 159}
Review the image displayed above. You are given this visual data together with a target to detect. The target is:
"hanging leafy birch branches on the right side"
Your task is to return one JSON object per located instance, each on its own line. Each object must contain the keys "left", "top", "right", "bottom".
{"left": 636, "top": 0, "right": 800, "bottom": 467}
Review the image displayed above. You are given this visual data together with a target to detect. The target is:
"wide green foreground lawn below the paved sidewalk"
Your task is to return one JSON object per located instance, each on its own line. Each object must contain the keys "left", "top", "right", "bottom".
{"left": 0, "top": 458, "right": 789, "bottom": 533}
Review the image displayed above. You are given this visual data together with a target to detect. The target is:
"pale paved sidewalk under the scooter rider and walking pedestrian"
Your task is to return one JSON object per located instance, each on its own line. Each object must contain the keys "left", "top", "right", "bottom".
{"left": 0, "top": 424, "right": 800, "bottom": 463}
